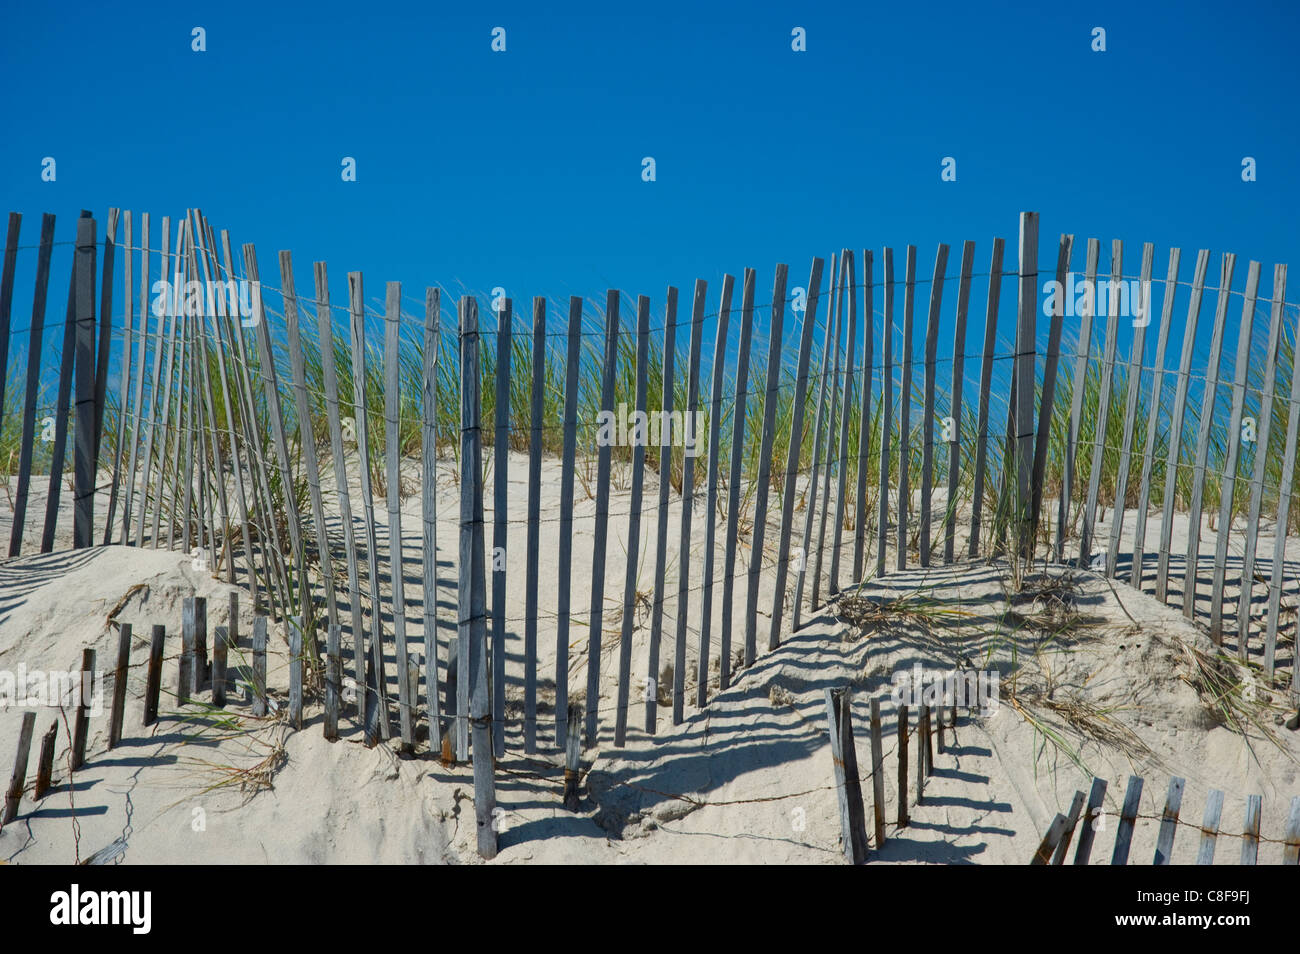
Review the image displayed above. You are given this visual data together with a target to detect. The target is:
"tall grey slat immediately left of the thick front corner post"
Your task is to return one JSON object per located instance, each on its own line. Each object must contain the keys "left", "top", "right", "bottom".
{"left": 428, "top": 289, "right": 449, "bottom": 753}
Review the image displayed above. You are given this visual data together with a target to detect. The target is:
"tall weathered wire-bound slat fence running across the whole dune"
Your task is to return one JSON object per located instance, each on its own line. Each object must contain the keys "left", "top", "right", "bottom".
{"left": 0, "top": 209, "right": 1300, "bottom": 857}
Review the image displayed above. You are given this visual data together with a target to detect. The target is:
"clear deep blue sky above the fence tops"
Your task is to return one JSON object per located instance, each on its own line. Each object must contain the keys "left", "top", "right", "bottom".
{"left": 0, "top": 0, "right": 1300, "bottom": 350}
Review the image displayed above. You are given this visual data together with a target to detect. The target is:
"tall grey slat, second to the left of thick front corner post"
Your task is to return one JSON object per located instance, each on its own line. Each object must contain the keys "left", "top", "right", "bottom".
{"left": 382, "top": 282, "right": 413, "bottom": 754}
